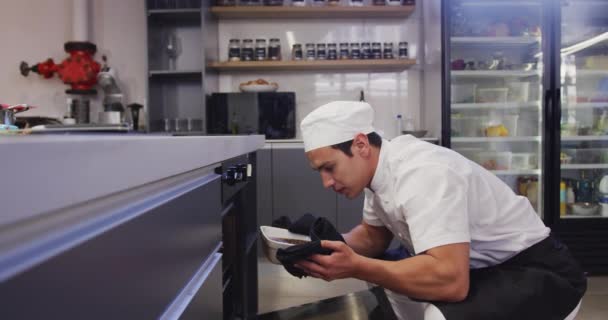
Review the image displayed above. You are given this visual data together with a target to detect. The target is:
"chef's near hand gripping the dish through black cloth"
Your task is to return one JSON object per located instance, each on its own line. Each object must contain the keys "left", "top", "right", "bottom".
{"left": 295, "top": 240, "right": 361, "bottom": 281}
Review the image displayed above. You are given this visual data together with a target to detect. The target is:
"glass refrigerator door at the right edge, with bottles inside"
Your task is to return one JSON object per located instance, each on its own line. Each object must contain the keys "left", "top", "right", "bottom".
{"left": 547, "top": 0, "right": 608, "bottom": 274}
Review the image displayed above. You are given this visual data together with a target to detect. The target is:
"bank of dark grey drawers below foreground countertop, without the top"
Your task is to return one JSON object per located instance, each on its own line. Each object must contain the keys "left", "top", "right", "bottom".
{"left": 0, "top": 170, "right": 222, "bottom": 319}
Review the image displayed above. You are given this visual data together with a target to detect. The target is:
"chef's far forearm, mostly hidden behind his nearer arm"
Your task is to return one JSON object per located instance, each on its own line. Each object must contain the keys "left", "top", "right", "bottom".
{"left": 343, "top": 223, "right": 392, "bottom": 257}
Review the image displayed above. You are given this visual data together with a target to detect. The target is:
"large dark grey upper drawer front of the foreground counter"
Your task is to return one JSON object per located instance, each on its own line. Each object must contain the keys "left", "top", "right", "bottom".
{"left": 0, "top": 175, "right": 222, "bottom": 319}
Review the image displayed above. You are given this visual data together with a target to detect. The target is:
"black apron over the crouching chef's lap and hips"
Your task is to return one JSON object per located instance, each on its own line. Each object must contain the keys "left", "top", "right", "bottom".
{"left": 431, "top": 236, "right": 587, "bottom": 320}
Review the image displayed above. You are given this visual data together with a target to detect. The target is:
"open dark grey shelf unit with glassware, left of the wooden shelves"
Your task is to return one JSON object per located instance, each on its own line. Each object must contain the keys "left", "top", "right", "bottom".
{"left": 146, "top": 0, "right": 217, "bottom": 132}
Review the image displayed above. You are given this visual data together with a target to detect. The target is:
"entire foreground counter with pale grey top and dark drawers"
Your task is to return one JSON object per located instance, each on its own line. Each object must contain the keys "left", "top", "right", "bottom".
{"left": 0, "top": 135, "right": 264, "bottom": 319}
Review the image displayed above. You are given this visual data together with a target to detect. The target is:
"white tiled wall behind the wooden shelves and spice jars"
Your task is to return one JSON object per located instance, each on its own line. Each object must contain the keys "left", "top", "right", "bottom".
{"left": 219, "top": 1, "right": 434, "bottom": 138}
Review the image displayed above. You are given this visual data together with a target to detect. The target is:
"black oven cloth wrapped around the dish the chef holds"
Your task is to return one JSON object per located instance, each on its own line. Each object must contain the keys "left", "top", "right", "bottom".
{"left": 276, "top": 217, "right": 346, "bottom": 278}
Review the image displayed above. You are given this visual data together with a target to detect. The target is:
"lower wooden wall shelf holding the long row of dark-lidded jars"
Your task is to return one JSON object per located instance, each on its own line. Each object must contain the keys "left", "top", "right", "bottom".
{"left": 208, "top": 59, "right": 416, "bottom": 72}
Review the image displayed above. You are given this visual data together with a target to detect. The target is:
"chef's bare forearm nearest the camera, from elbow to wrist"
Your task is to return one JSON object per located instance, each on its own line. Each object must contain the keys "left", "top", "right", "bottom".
{"left": 355, "top": 254, "right": 468, "bottom": 302}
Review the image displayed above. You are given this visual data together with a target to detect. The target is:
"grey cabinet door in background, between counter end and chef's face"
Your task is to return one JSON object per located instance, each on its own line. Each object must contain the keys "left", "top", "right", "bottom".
{"left": 272, "top": 147, "right": 336, "bottom": 225}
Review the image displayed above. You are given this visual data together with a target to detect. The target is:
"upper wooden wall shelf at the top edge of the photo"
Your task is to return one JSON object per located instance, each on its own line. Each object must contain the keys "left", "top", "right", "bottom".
{"left": 211, "top": 6, "right": 415, "bottom": 19}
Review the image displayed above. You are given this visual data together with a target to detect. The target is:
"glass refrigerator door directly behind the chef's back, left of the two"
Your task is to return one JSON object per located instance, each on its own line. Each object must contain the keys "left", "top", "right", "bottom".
{"left": 442, "top": 0, "right": 548, "bottom": 216}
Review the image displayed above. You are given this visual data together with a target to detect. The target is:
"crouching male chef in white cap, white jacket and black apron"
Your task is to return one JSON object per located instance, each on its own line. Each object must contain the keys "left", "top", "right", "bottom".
{"left": 296, "top": 101, "right": 587, "bottom": 320}
